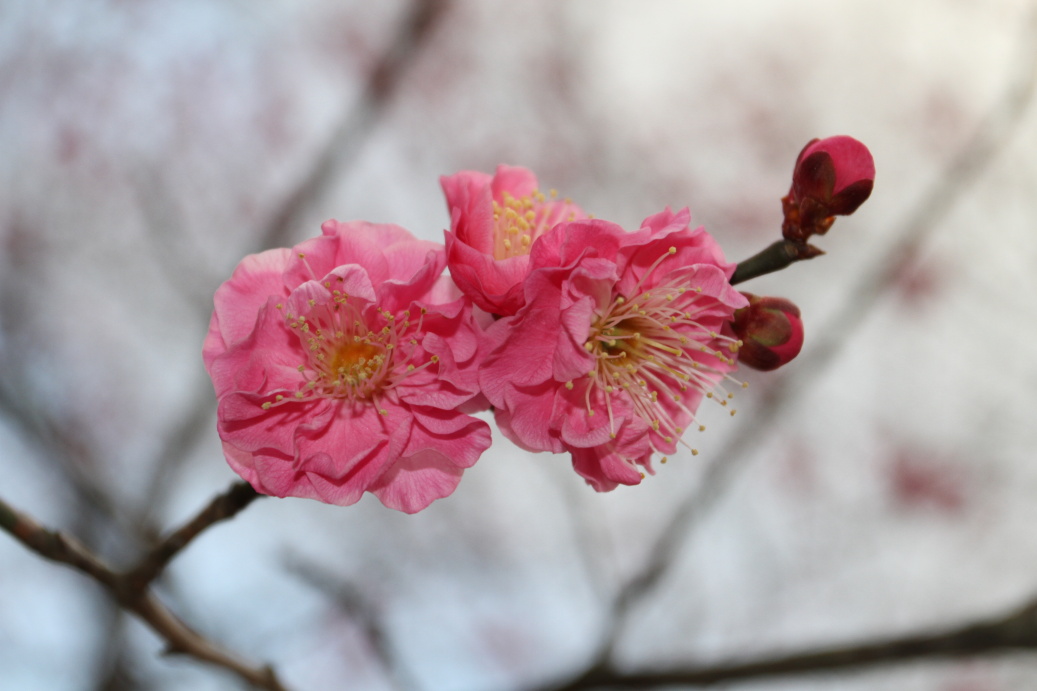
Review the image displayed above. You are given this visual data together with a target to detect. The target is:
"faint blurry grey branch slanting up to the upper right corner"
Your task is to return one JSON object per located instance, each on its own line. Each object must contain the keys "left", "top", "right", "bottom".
{"left": 539, "top": 5, "right": 1037, "bottom": 688}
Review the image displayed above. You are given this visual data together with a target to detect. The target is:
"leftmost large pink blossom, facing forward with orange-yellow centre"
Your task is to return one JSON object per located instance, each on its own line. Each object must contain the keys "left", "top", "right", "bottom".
{"left": 203, "top": 221, "right": 489, "bottom": 513}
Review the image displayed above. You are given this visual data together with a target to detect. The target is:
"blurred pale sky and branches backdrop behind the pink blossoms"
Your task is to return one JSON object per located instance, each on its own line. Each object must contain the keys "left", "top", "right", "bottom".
{"left": 0, "top": 0, "right": 1037, "bottom": 691}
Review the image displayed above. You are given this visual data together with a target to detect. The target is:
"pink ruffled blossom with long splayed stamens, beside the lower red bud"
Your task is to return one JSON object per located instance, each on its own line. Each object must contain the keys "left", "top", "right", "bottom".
{"left": 479, "top": 209, "right": 747, "bottom": 491}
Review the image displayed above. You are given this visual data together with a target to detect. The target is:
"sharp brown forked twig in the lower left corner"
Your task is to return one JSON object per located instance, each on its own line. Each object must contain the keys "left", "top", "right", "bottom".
{"left": 0, "top": 482, "right": 285, "bottom": 691}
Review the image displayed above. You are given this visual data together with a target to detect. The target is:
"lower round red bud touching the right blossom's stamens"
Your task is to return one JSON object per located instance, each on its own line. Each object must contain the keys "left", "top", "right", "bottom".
{"left": 731, "top": 293, "right": 803, "bottom": 371}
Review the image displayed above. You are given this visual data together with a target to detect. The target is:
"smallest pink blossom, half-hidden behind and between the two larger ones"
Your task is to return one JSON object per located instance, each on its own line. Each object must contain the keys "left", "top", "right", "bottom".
{"left": 440, "top": 166, "right": 586, "bottom": 315}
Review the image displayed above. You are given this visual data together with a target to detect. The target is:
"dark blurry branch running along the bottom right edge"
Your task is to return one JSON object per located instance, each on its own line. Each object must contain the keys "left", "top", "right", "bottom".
{"left": 553, "top": 600, "right": 1037, "bottom": 691}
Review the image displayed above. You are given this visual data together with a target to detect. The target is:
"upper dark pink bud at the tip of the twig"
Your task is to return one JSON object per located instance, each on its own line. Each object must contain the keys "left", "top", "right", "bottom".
{"left": 782, "top": 135, "right": 875, "bottom": 242}
